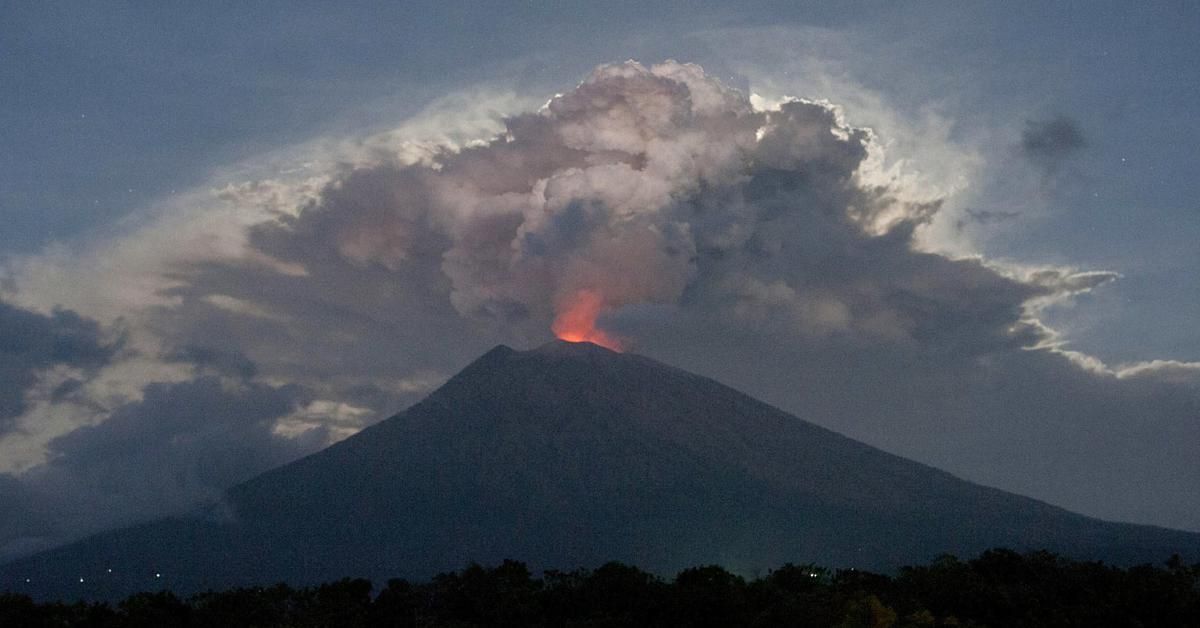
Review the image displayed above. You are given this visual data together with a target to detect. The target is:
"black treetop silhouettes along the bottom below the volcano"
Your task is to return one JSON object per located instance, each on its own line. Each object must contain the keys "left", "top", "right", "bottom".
{"left": 0, "top": 550, "right": 1200, "bottom": 628}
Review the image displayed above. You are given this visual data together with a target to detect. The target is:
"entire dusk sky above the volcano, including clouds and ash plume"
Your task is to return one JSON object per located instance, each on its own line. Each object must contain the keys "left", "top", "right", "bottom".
{"left": 0, "top": 2, "right": 1200, "bottom": 556}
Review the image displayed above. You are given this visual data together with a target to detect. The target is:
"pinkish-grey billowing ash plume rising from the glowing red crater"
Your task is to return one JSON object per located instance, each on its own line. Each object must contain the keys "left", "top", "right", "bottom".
{"left": 256, "top": 61, "right": 929, "bottom": 347}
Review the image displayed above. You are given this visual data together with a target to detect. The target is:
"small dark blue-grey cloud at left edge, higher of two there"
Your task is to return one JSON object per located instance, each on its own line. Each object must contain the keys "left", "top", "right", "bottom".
{"left": 0, "top": 301, "right": 120, "bottom": 436}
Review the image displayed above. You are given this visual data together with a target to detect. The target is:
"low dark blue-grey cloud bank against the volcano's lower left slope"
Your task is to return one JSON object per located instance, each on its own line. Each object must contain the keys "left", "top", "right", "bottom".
{"left": 0, "top": 376, "right": 328, "bottom": 556}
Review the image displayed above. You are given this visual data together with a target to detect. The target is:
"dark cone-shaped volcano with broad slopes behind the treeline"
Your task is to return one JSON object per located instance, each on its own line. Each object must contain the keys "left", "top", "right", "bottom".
{"left": 7, "top": 342, "right": 1200, "bottom": 598}
